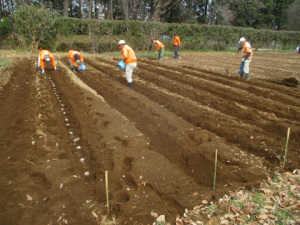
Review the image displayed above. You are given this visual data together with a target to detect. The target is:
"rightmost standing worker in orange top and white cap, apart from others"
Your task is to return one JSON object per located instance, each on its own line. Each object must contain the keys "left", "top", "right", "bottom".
{"left": 237, "top": 37, "right": 253, "bottom": 81}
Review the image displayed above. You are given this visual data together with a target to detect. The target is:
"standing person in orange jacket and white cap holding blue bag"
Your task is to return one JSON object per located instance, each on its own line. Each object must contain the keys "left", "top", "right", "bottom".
{"left": 118, "top": 40, "right": 137, "bottom": 89}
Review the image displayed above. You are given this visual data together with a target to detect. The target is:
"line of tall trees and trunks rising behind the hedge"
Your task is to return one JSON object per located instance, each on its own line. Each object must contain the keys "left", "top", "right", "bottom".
{"left": 0, "top": 0, "right": 300, "bottom": 31}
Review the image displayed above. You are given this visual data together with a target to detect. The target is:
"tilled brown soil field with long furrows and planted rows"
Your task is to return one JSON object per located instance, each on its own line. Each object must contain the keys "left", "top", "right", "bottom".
{"left": 0, "top": 52, "right": 300, "bottom": 225}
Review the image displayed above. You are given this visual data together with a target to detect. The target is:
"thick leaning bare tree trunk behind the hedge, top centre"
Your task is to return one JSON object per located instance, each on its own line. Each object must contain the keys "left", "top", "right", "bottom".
{"left": 150, "top": 0, "right": 182, "bottom": 22}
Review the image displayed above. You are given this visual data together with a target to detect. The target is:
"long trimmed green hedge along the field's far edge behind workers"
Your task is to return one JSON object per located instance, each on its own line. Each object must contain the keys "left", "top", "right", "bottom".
{"left": 0, "top": 17, "right": 300, "bottom": 52}
